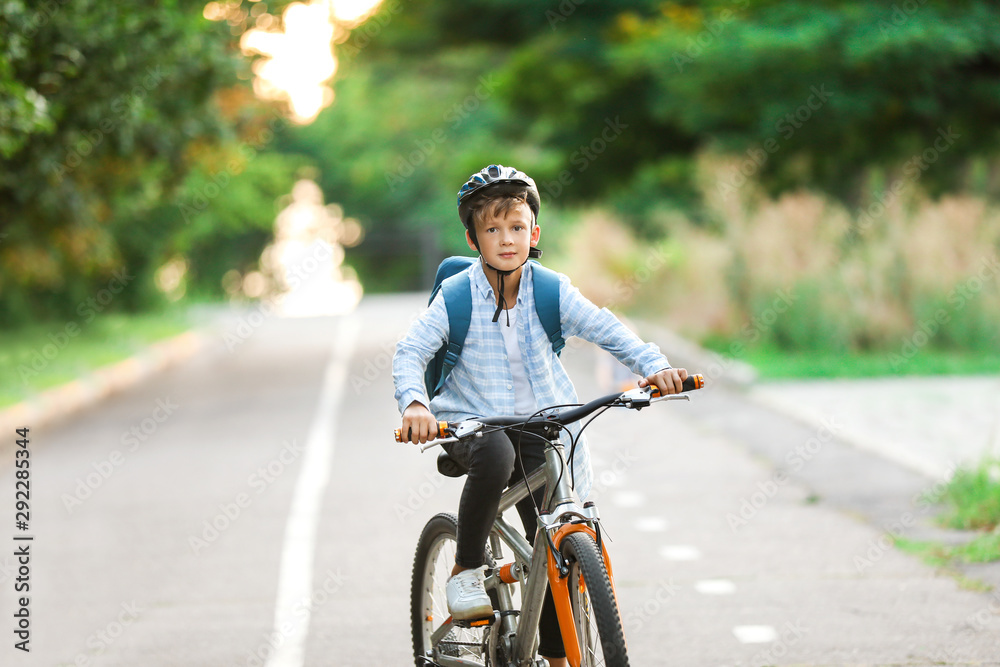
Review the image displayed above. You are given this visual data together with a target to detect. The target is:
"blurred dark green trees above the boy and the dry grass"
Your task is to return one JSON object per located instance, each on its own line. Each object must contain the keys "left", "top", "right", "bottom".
{"left": 283, "top": 0, "right": 1000, "bottom": 290}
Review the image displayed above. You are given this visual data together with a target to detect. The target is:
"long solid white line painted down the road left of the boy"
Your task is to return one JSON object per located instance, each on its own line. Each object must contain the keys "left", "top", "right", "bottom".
{"left": 267, "top": 315, "right": 360, "bottom": 667}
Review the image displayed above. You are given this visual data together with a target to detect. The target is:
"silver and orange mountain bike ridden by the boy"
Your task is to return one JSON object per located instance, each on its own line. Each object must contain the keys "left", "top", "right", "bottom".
{"left": 396, "top": 375, "right": 704, "bottom": 667}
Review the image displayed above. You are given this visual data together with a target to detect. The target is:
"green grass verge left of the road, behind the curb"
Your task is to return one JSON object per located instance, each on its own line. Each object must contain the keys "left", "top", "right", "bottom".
{"left": 0, "top": 309, "right": 190, "bottom": 408}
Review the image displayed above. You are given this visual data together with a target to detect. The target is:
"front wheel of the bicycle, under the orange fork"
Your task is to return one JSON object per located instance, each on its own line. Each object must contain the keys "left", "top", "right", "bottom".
{"left": 559, "top": 533, "right": 628, "bottom": 667}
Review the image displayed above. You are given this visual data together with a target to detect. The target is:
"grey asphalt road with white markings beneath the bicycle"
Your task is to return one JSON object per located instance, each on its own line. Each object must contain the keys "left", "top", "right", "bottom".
{"left": 0, "top": 296, "right": 1000, "bottom": 667}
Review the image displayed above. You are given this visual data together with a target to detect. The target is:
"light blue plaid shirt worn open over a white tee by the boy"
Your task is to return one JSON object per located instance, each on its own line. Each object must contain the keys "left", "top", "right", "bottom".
{"left": 392, "top": 262, "right": 670, "bottom": 498}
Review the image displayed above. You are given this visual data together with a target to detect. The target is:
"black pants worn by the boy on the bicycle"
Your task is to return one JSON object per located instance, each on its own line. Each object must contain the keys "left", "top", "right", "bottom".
{"left": 444, "top": 431, "right": 566, "bottom": 658}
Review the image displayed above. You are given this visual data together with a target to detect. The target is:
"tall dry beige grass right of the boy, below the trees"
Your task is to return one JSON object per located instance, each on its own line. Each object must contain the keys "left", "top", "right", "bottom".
{"left": 567, "top": 156, "right": 1000, "bottom": 351}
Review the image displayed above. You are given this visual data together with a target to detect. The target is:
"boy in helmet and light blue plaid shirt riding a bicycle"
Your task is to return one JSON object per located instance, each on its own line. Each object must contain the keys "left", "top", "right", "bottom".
{"left": 393, "top": 165, "right": 687, "bottom": 667}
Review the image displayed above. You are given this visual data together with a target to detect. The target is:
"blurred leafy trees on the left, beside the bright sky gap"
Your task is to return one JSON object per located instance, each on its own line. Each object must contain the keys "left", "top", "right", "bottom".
{"left": 0, "top": 0, "right": 295, "bottom": 326}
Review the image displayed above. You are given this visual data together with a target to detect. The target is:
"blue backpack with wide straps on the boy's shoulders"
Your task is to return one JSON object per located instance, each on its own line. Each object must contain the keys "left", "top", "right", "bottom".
{"left": 424, "top": 256, "right": 566, "bottom": 398}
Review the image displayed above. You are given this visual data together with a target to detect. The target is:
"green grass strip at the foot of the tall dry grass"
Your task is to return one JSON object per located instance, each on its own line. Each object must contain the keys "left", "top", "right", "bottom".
{"left": 705, "top": 341, "right": 1000, "bottom": 380}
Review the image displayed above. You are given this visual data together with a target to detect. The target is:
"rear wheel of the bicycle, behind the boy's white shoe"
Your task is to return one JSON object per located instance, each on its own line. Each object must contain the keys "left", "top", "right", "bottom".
{"left": 410, "top": 513, "right": 489, "bottom": 667}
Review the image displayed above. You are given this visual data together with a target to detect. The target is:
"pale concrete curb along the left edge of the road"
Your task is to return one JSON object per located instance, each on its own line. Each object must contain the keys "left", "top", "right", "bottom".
{"left": 0, "top": 330, "right": 206, "bottom": 438}
